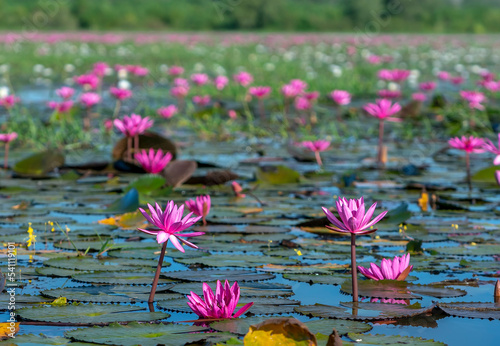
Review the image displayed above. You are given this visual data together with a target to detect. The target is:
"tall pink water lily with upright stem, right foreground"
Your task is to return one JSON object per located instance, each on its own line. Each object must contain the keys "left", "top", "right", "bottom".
{"left": 322, "top": 197, "right": 387, "bottom": 302}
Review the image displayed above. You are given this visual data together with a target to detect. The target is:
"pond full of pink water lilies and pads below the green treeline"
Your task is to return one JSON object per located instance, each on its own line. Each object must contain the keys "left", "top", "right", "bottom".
{"left": 0, "top": 34, "right": 500, "bottom": 345}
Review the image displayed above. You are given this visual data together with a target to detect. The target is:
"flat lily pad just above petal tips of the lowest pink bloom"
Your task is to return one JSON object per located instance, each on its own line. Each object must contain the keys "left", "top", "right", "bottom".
{"left": 161, "top": 269, "right": 275, "bottom": 282}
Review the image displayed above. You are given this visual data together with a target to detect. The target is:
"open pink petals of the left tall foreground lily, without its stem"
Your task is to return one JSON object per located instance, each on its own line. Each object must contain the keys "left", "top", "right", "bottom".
{"left": 138, "top": 201, "right": 205, "bottom": 252}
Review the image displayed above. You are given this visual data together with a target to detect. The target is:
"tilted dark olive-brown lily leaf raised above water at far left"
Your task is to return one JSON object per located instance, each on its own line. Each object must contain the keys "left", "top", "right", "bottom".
{"left": 13, "top": 150, "right": 64, "bottom": 177}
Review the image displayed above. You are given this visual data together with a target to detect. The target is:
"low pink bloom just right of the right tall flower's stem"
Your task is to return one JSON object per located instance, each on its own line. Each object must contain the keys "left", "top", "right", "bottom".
{"left": 358, "top": 254, "right": 413, "bottom": 281}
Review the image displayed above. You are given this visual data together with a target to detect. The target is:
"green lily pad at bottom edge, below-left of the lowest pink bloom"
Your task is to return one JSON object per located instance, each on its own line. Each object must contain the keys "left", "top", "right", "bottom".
{"left": 65, "top": 322, "right": 234, "bottom": 346}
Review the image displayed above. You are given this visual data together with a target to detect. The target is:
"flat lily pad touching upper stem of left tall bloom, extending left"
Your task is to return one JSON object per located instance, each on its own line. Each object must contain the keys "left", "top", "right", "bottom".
{"left": 44, "top": 257, "right": 163, "bottom": 272}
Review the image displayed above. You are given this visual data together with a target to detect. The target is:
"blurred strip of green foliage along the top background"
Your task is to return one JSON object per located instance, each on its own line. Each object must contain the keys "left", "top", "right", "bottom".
{"left": 0, "top": 0, "right": 500, "bottom": 33}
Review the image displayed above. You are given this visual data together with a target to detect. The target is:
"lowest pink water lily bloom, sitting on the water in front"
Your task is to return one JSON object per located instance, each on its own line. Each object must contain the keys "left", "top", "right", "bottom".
{"left": 187, "top": 280, "right": 253, "bottom": 319}
